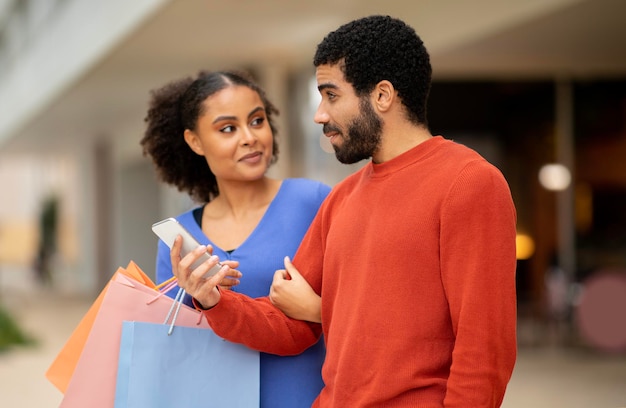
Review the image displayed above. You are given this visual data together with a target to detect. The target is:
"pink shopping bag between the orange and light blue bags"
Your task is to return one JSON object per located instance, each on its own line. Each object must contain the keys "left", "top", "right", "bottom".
{"left": 60, "top": 268, "right": 256, "bottom": 408}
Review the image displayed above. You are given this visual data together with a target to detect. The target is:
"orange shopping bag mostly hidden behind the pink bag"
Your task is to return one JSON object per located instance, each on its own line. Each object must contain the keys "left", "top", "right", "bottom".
{"left": 46, "top": 261, "right": 155, "bottom": 393}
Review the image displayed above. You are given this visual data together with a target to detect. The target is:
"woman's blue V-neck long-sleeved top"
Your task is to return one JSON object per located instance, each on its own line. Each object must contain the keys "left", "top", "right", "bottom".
{"left": 156, "top": 179, "right": 330, "bottom": 408}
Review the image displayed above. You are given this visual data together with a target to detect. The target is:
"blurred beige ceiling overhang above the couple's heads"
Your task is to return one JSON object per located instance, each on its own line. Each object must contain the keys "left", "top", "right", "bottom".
{"left": 3, "top": 0, "right": 626, "bottom": 153}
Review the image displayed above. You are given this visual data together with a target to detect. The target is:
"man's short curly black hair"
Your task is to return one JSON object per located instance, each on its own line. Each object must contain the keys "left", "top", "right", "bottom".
{"left": 313, "top": 15, "right": 432, "bottom": 126}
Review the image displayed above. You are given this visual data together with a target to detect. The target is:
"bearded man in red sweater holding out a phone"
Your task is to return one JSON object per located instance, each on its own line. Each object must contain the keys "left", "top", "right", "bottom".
{"left": 172, "top": 16, "right": 516, "bottom": 408}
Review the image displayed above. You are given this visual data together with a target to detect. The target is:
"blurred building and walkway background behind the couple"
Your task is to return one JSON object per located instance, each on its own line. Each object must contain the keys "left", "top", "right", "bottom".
{"left": 0, "top": 0, "right": 626, "bottom": 408}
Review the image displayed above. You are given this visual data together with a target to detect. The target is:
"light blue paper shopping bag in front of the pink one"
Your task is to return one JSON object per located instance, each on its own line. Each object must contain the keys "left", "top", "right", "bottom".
{"left": 115, "top": 321, "right": 260, "bottom": 408}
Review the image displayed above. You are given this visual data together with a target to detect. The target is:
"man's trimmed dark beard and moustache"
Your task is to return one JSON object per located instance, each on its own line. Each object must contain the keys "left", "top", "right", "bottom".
{"left": 324, "top": 98, "right": 382, "bottom": 164}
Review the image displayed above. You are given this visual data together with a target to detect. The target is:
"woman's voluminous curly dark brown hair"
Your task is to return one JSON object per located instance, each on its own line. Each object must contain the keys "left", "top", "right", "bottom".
{"left": 140, "top": 71, "right": 279, "bottom": 203}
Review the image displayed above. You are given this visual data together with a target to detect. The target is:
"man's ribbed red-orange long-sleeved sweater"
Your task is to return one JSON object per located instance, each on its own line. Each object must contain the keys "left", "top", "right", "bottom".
{"left": 205, "top": 136, "right": 516, "bottom": 408}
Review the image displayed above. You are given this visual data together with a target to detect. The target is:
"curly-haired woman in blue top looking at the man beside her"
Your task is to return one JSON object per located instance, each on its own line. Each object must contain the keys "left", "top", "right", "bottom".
{"left": 141, "top": 71, "right": 330, "bottom": 408}
